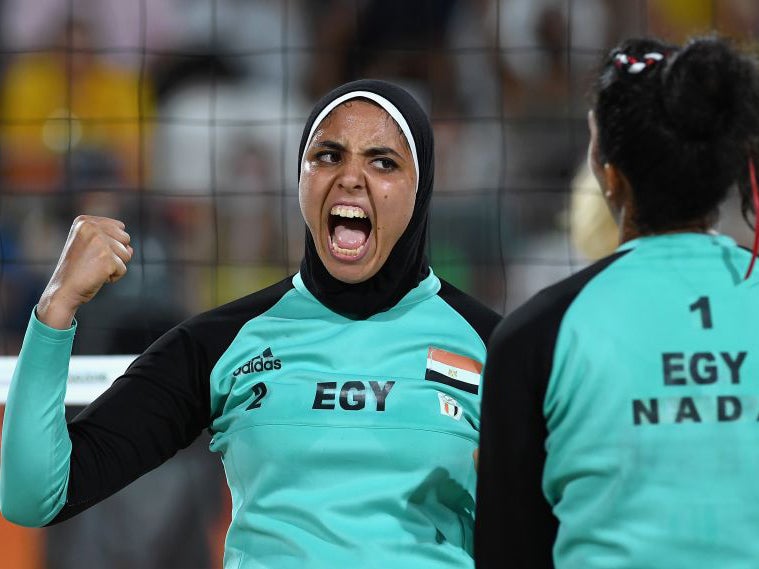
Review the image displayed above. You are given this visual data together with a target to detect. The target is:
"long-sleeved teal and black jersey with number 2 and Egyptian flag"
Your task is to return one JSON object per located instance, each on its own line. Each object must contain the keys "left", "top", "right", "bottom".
{"left": 0, "top": 273, "right": 497, "bottom": 569}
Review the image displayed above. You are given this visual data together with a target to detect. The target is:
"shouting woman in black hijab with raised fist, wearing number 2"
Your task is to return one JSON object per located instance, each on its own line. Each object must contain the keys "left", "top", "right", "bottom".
{"left": 0, "top": 80, "right": 498, "bottom": 569}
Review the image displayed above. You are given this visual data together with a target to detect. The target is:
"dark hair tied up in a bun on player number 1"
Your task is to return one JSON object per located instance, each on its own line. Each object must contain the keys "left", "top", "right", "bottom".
{"left": 595, "top": 38, "right": 759, "bottom": 232}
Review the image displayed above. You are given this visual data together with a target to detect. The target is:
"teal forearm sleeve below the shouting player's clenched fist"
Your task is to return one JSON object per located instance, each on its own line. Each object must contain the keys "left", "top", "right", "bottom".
{"left": 0, "top": 309, "right": 76, "bottom": 527}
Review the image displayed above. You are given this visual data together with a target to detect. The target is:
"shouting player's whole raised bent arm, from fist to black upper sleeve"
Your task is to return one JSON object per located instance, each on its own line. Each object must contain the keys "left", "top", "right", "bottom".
{"left": 0, "top": 216, "right": 209, "bottom": 526}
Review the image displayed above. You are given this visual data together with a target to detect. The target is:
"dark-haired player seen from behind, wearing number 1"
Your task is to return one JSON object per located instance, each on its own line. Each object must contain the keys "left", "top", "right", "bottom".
{"left": 475, "top": 39, "right": 759, "bottom": 569}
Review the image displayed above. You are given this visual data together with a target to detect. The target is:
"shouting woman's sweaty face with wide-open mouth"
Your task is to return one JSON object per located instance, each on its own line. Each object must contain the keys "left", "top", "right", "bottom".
{"left": 299, "top": 101, "right": 417, "bottom": 283}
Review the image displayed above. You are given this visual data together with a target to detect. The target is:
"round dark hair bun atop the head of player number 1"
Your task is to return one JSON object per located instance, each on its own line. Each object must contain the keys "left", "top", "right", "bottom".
{"left": 662, "top": 38, "right": 757, "bottom": 140}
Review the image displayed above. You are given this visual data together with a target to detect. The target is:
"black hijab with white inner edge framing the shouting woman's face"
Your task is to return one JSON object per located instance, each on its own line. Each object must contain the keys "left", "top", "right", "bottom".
{"left": 298, "top": 79, "right": 434, "bottom": 320}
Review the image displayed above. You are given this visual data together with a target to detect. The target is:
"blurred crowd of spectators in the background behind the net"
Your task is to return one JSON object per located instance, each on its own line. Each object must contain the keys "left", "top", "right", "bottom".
{"left": 0, "top": 0, "right": 759, "bottom": 569}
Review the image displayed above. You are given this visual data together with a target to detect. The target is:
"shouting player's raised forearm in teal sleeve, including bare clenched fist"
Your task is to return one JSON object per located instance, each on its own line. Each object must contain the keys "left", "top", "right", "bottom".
{"left": 0, "top": 216, "right": 132, "bottom": 526}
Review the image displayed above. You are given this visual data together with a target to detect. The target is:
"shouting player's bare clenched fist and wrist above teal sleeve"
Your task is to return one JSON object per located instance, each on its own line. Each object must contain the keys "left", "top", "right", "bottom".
{"left": 37, "top": 215, "right": 133, "bottom": 329}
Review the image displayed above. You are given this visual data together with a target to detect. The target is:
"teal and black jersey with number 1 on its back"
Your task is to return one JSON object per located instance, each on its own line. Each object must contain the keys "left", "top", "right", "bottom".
{"left": 476, "top": 234, "right": 759, "bottom": 569}
